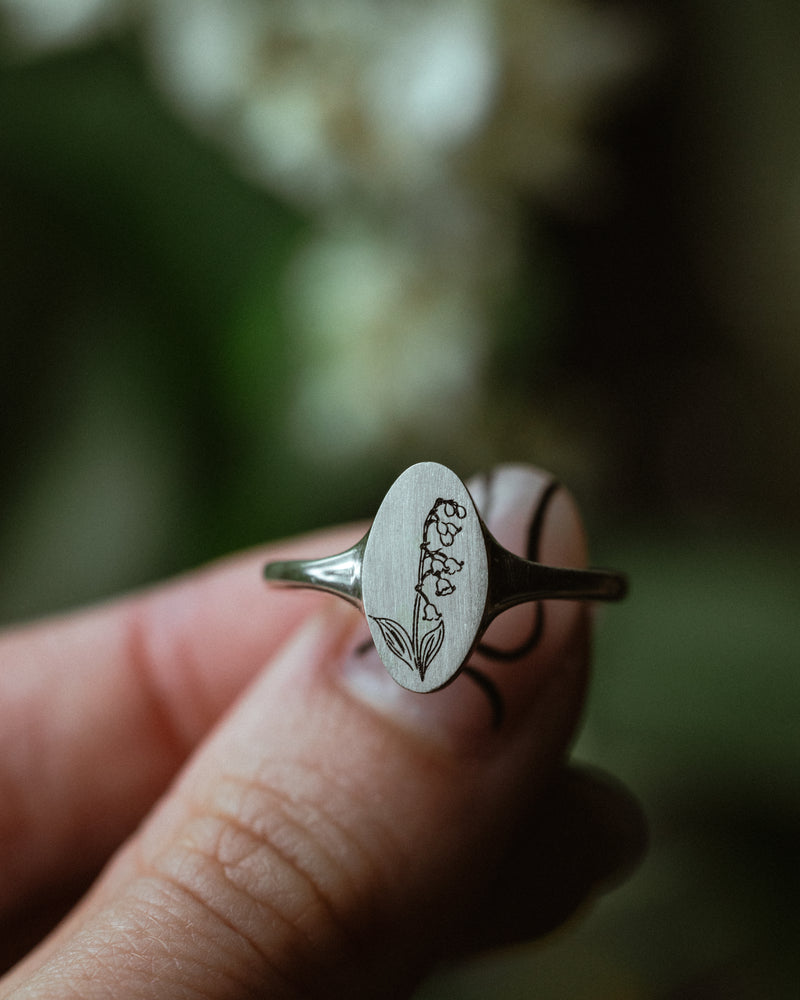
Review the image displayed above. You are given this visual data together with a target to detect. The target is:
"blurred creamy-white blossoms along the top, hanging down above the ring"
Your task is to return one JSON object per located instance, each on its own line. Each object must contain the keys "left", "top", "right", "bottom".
{"left": 0, "top": 0, "right": 652, "bottom": 458}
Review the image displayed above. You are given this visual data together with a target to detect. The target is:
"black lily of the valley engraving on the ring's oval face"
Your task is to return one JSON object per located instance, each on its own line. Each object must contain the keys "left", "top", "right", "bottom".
{"left": 370, "top": 497, "right": 467, "bottom": 680}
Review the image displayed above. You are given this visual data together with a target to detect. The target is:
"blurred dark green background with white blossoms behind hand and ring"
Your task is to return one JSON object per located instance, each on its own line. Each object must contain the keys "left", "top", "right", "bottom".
{"left": 0, "top": 0, "right": 800, "bottom": 1000}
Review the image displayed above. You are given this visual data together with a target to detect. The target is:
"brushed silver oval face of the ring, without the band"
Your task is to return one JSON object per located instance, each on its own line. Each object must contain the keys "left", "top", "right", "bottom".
{"left": 361, "top": 462, "right": 489, "bottom": 691}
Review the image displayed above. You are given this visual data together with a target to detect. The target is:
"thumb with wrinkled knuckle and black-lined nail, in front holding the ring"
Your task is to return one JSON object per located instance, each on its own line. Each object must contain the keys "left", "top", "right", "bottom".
{"left": 4, "top": 468, "right": 600, "bottom": 1000}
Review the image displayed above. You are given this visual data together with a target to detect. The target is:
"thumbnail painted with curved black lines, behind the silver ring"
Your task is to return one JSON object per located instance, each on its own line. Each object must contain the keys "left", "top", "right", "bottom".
{"left": 343, "top": 465, "right": 585, "bottom": 744}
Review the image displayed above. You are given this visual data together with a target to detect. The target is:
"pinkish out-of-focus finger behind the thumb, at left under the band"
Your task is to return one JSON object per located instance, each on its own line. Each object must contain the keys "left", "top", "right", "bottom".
{"left": 0, "top": 527, "right": 363, "bottom": 915}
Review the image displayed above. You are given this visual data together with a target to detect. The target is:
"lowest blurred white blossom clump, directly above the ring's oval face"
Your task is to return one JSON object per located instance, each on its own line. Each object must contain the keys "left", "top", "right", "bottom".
{"left": 292, "top": 226, "right": 485, "bottom": 460}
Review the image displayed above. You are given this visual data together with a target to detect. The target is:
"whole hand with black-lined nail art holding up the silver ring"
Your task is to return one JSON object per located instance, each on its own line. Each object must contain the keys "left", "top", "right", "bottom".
{"left": 0, "top": 467, "right": 644, "bottom": 1000}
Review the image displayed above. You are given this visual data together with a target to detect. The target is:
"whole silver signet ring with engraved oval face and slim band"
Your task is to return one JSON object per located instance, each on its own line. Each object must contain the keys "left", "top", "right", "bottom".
{"left": 264, "top": 462, "right": 627, "bottom": 692}
